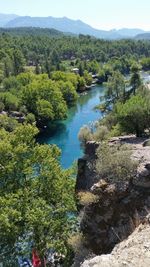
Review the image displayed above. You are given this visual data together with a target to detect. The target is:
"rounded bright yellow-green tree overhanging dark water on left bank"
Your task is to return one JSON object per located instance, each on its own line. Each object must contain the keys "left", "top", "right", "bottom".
{"left": 21, "top": 75, "right": 67, "bottom": 123}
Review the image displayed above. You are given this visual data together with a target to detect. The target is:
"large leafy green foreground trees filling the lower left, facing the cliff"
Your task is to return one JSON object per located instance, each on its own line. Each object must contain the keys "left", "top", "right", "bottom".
{"left": 0, "top": 125, "right": 75, "bottom": 266}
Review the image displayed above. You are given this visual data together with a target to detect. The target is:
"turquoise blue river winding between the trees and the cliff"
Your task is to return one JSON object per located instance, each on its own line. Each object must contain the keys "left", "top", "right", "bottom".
{"left": 39, "top": 86, "right": 104, "bottom": 168}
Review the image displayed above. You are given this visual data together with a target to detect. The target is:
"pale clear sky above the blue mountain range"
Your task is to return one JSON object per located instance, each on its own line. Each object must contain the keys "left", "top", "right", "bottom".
{"left": 0, "top": 0, "right": 150, "bottom": 30}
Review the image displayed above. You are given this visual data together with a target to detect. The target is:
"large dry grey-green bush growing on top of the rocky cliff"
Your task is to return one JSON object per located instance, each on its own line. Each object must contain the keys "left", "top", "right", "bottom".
{"left": 96, "top": 144, "right": 137, "bottom": 182}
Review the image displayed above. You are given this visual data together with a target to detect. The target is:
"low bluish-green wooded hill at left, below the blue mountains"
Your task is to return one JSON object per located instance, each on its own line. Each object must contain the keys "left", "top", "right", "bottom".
{"left": 0, "top": 27, "right": 63, "bottom": 37}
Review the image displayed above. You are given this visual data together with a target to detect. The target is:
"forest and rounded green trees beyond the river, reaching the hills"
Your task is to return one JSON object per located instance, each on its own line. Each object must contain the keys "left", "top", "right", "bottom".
{"left": 0, "top": 28, "right": 150, "bottom": 127}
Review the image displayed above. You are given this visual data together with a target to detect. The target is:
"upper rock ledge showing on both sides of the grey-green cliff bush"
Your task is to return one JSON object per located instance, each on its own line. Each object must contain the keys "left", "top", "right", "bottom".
{"left": 76, "top": 135, "right": 150, "bottom": 191}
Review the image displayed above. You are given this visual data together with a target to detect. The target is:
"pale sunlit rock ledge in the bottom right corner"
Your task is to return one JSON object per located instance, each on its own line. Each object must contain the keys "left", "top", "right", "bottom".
{"left": 81, "top": 217, "right": 150, "bottom": 267}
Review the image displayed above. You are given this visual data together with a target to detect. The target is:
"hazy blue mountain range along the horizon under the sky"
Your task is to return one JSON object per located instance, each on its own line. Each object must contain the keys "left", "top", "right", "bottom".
{"left": 0, "top": 14, "right": 149, "bottom": 39}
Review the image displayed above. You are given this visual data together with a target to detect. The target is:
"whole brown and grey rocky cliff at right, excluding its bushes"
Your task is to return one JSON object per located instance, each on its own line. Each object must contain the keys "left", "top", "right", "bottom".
{"left": 75, "top": 136, "right": 150, "bottom": 267}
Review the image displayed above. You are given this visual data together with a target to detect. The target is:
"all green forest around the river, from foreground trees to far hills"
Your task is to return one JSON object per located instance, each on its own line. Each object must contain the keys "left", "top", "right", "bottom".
{"left": 0, "top": 28, "right": 150, "bottom": 267}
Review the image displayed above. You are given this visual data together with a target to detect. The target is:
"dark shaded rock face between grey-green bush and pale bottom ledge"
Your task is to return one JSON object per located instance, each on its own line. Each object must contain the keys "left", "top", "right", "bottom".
{"left": 81, "top": 181, "right": 150, "bottom": 255}
